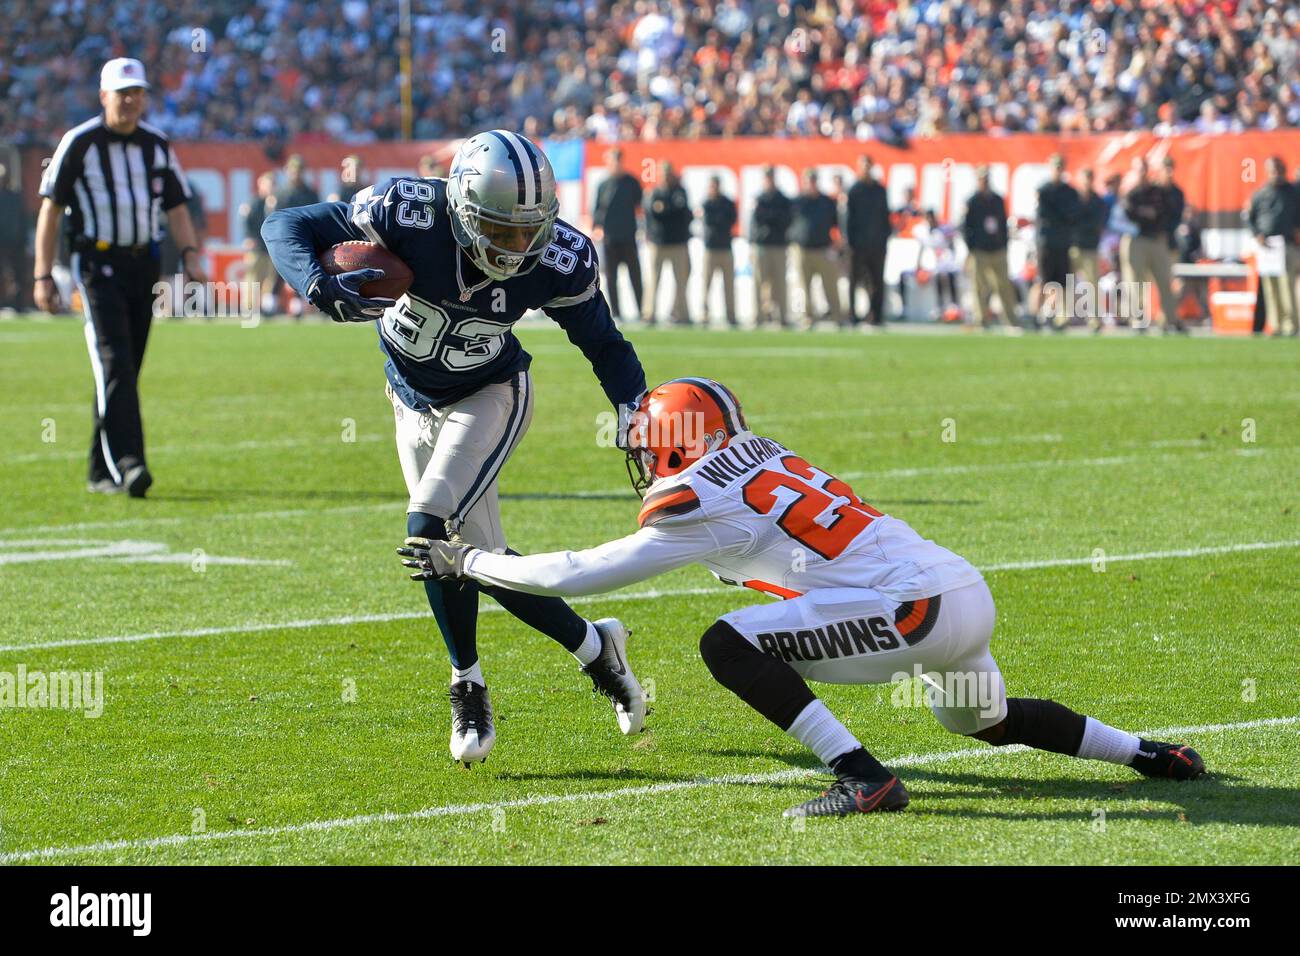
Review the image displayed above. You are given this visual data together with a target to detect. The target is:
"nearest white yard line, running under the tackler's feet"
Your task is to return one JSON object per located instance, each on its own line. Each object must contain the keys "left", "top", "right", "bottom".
{"left": 0, "top": 717, "right": 1300, "bottom": 865}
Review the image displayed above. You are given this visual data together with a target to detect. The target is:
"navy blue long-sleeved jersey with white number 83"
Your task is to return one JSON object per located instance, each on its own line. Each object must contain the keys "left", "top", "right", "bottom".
{"left": 261, "top": 178, "right": 645, "bottom": 410}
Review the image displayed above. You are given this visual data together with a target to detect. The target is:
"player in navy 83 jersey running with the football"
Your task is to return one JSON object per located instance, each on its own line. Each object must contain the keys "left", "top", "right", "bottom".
{"left": 261, "top": 130, "right": 646, "bottom": 766}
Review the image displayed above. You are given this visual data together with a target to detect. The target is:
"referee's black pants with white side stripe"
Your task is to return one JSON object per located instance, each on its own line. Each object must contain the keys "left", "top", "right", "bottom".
{"left": 72, "top": 248, "right": 159, "bottom": 484}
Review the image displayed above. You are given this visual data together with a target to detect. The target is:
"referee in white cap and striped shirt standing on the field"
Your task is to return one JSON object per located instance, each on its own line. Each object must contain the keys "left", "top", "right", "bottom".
{"left": 34, "top": 59, "right": 207, "bottom": 498}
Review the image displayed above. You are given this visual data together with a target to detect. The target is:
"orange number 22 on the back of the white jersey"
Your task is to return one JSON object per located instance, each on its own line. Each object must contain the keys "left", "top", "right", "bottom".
{"left": 741, "top": 455, "right": 883, "bottom": 561}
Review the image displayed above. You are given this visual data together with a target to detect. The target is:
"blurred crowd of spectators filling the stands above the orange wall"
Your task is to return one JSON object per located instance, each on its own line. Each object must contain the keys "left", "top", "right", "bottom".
{"left": 0, "top": 0, "right": 1300, "bottom": 146}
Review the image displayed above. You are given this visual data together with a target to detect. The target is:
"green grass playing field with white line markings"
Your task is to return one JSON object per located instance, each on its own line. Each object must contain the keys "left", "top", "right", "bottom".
{"left": 0, "top": 320, "right": 1300, "bottom": 865}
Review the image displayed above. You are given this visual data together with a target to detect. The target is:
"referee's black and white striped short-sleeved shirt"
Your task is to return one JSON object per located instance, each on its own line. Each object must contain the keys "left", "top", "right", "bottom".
{"left": 40, "top": 114, "right": 190, "bottom": 250}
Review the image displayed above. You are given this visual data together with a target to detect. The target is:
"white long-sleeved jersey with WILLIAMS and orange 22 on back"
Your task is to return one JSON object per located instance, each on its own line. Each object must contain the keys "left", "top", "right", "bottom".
{"left": 465, "top": 432, "right": 982, "bottom": 602}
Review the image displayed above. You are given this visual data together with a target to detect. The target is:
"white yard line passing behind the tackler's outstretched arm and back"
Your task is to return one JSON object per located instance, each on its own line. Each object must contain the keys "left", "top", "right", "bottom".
{"left": 0, "top": 540, "right": 1300, "bottom": 653}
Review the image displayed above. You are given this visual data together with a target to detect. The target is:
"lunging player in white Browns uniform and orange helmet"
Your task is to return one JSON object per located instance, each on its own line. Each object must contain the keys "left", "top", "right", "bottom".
{"left": 399, "top": 378, "right": 1205, "bottom": 817}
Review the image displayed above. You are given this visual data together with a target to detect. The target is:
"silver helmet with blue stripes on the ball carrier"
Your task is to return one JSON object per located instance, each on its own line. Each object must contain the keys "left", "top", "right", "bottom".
{"left": 447, "top": 130, "right": 560, "bottom": 281}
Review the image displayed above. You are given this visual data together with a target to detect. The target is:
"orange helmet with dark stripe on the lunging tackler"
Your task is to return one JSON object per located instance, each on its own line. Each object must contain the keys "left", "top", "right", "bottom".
{"left": 627, "top": 378, "right": 749, "bottom": 497}
